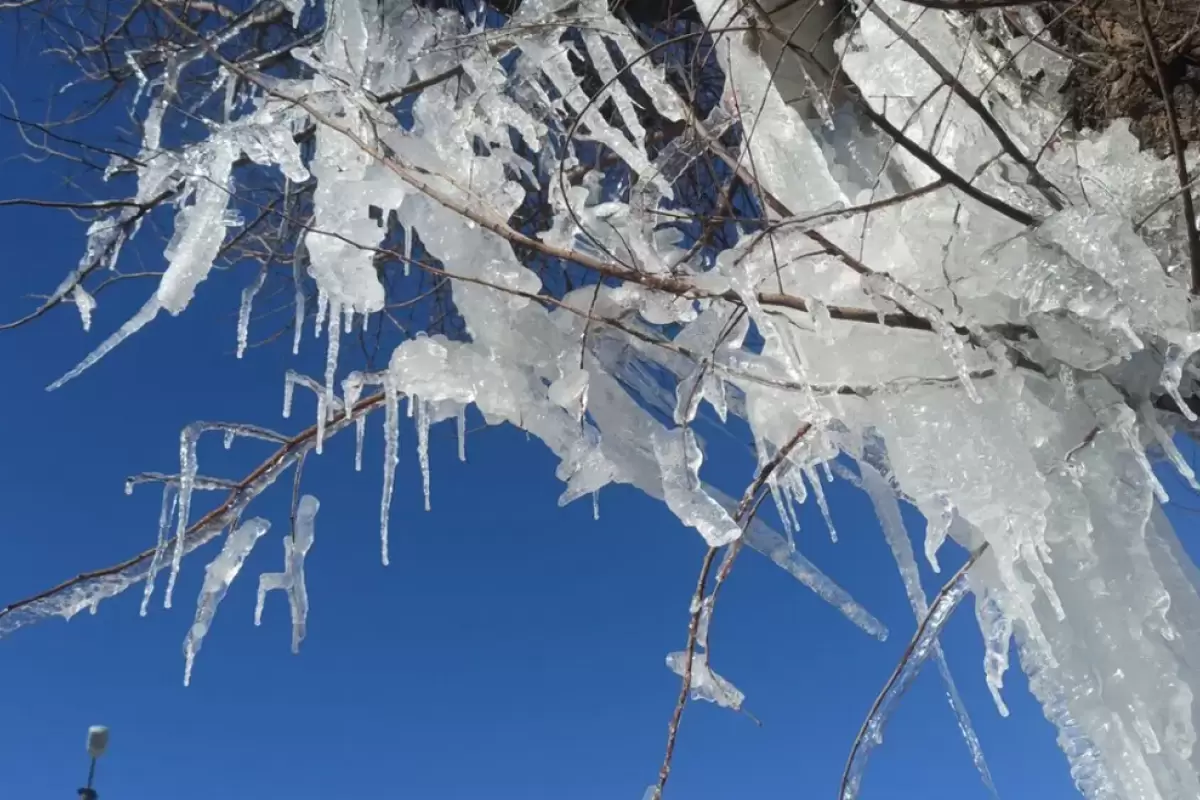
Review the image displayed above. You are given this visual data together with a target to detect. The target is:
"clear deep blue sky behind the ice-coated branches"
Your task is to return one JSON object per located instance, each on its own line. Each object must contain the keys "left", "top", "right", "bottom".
{"left": 0, "top": 20, "right": 1196, "bottom": 800}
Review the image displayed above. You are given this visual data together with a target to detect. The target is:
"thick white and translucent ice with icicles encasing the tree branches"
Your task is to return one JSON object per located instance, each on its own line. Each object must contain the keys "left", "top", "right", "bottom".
{"left": 11, "top": 0, "right": 1200, "bottom": 800}
